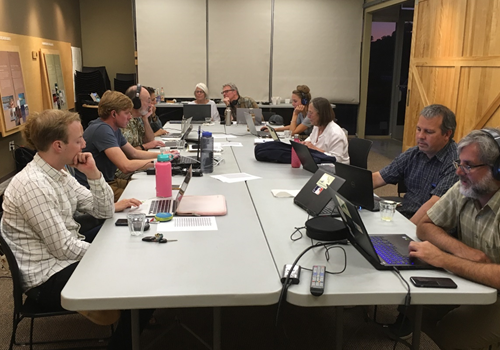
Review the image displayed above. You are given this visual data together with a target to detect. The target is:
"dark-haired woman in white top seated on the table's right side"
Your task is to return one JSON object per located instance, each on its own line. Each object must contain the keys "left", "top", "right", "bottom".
{"left": 303, "top": 97, "right": 349, "bottom": 164}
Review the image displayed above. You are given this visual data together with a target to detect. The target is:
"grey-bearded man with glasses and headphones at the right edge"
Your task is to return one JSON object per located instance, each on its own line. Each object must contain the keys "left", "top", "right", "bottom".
{"left": 410, "top": 129, "right": 500, "bottom": 349}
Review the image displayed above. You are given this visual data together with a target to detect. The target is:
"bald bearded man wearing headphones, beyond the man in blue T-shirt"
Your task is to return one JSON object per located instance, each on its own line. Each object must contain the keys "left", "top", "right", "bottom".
{"left": 122, "top": 84, "right": 165, "bottom": 151}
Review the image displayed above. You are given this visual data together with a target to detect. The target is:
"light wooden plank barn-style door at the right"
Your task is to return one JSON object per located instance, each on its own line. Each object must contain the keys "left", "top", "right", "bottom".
{"left": 403, "top": 0, "right": 500, "bottom": 150}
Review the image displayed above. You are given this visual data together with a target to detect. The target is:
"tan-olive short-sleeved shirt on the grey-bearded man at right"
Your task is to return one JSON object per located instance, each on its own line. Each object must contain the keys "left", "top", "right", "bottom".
{"left": 427, "top": 182, "right": 500, "bottom": 264}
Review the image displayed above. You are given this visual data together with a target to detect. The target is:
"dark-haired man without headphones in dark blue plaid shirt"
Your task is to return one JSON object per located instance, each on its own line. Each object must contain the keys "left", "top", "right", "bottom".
{"left": 372, "top": 104, "right": 458, "bottom": 224}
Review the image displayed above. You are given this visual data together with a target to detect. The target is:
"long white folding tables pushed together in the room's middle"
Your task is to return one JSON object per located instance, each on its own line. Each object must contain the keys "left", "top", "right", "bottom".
{"left": 62, "top": 121, "right": 497, "bottom": 349}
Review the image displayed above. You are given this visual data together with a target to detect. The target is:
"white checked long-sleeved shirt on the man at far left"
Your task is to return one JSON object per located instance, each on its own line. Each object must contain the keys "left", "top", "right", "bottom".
{"left": 1, "top": 153, "right": 114, "bottom": 291}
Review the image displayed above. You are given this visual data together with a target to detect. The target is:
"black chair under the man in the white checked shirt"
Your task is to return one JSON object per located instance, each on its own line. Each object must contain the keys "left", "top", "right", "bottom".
{"left": 0, "top": 226, "right": 113, "bottom": 350}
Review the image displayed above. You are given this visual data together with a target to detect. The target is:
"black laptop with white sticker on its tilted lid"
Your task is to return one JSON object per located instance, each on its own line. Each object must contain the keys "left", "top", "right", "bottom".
{"left": 293, "top": 168, "right": 345, "bottom": 216}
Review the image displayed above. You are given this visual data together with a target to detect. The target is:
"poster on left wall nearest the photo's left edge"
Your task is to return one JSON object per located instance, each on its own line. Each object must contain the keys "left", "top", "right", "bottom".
{"left": 0, "top": 51, "right": 29, "bottom": 131}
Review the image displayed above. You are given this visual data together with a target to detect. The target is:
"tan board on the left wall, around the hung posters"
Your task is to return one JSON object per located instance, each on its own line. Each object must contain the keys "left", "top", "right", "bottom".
{"left": 0, "top": 32, "right": 75, "bottom": 137}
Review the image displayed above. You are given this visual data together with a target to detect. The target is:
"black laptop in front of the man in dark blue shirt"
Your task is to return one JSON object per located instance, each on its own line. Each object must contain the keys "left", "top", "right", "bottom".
{"left": 335, "top": 163, "right": 380, "bottom": 211}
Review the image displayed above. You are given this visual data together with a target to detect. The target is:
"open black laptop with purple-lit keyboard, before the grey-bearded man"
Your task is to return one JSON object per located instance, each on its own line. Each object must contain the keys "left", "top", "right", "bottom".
{"left": 328, "top": 187, "right": 437, "bottom": 270}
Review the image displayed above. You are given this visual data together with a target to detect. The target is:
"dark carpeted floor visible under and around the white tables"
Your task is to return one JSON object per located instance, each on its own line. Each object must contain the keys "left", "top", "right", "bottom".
{"left": 0, "top": 140, "right": 438, "bottom": 350}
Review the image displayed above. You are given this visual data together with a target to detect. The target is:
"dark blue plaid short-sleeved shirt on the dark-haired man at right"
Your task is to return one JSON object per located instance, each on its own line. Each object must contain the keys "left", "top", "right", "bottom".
{"left": 380, "top": 140, "right": 458, "bottom": 216}
